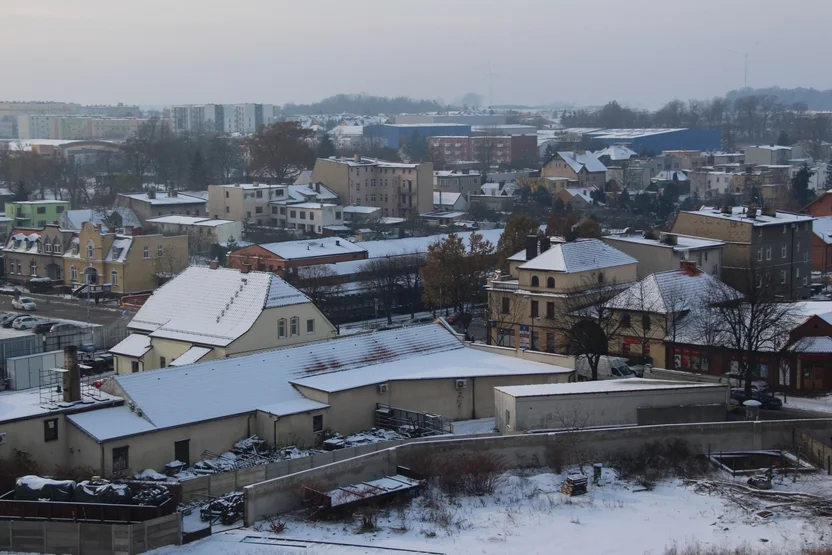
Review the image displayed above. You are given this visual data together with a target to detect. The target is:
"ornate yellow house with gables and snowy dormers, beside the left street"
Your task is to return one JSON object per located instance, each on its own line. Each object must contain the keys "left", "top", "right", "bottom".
{"left": 63, "top": 222, "right": 188, "bottom": 294}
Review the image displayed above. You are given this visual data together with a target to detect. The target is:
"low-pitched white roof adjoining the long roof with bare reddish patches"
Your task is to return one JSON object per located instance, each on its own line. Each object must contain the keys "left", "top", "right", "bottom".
{"left": 292, "top": 340, "right": 574, "bottom": 393}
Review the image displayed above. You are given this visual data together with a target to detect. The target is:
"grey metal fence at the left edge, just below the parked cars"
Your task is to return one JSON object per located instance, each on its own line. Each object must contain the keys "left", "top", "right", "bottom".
{"left": 0, "top": 323, "right": 128, "bottom": 368}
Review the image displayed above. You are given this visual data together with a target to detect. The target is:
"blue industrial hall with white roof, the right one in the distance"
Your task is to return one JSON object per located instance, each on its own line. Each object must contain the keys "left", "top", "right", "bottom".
{"left": 584, "top": 129, "right": 722, "bottom": 155}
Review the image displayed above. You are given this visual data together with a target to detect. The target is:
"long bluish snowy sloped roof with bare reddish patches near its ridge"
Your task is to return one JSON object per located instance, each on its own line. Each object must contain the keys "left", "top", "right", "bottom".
{"left": 110, "top": 324, "right": 462, "bottom": 428}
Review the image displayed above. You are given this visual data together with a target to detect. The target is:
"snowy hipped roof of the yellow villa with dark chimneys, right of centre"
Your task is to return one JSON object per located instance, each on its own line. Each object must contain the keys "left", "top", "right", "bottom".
{"left": 520, "top": 239, "right": 638, "bottom": 273}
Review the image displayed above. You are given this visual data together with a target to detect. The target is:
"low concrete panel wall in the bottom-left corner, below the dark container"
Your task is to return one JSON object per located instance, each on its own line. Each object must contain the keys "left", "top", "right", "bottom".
{"left": 0, "top": 513, "right": 182, "bottom": 555}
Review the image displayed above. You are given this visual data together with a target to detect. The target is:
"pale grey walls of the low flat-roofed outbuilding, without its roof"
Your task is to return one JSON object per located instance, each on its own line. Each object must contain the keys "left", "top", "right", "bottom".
{"left": 494, "top": 385, "right": 728, "bottom": 433}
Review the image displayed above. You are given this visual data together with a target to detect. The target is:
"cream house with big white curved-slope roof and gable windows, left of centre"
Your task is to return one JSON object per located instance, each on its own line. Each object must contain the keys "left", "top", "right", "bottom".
{"left": 110, "top": 265, "right": 337, "bottom": 374}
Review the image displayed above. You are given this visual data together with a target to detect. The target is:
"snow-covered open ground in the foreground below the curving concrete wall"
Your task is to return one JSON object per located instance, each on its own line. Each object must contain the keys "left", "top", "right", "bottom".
{"left": 154, "top": 469, "right": 832, "bottom": 555}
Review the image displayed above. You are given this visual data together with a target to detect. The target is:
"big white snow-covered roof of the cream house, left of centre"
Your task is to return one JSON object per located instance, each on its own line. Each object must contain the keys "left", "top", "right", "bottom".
{"left": 128, "top": 266, "right": 311, "bottom": 346}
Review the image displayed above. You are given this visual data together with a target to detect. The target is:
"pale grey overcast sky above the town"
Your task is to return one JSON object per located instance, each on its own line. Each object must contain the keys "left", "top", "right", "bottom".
{"left": 0, "top": 0, "right": 832, "bottom": 108}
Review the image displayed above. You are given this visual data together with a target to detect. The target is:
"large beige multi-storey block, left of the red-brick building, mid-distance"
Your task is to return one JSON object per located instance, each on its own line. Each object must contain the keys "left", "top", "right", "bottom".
{"left": 312, "top": 155, "right": 433, "bottom": 218}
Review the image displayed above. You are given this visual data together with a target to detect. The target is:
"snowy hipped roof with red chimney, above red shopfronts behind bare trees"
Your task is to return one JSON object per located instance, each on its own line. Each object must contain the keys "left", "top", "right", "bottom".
{"left": 607, "top": 270, "right": 742, "bottom": 314}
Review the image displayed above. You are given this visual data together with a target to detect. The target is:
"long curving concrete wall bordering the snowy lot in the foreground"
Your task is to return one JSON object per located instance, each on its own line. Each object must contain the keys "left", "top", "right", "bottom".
{"left": 243, "top": 419, "right": 832, "bottom": 526}
